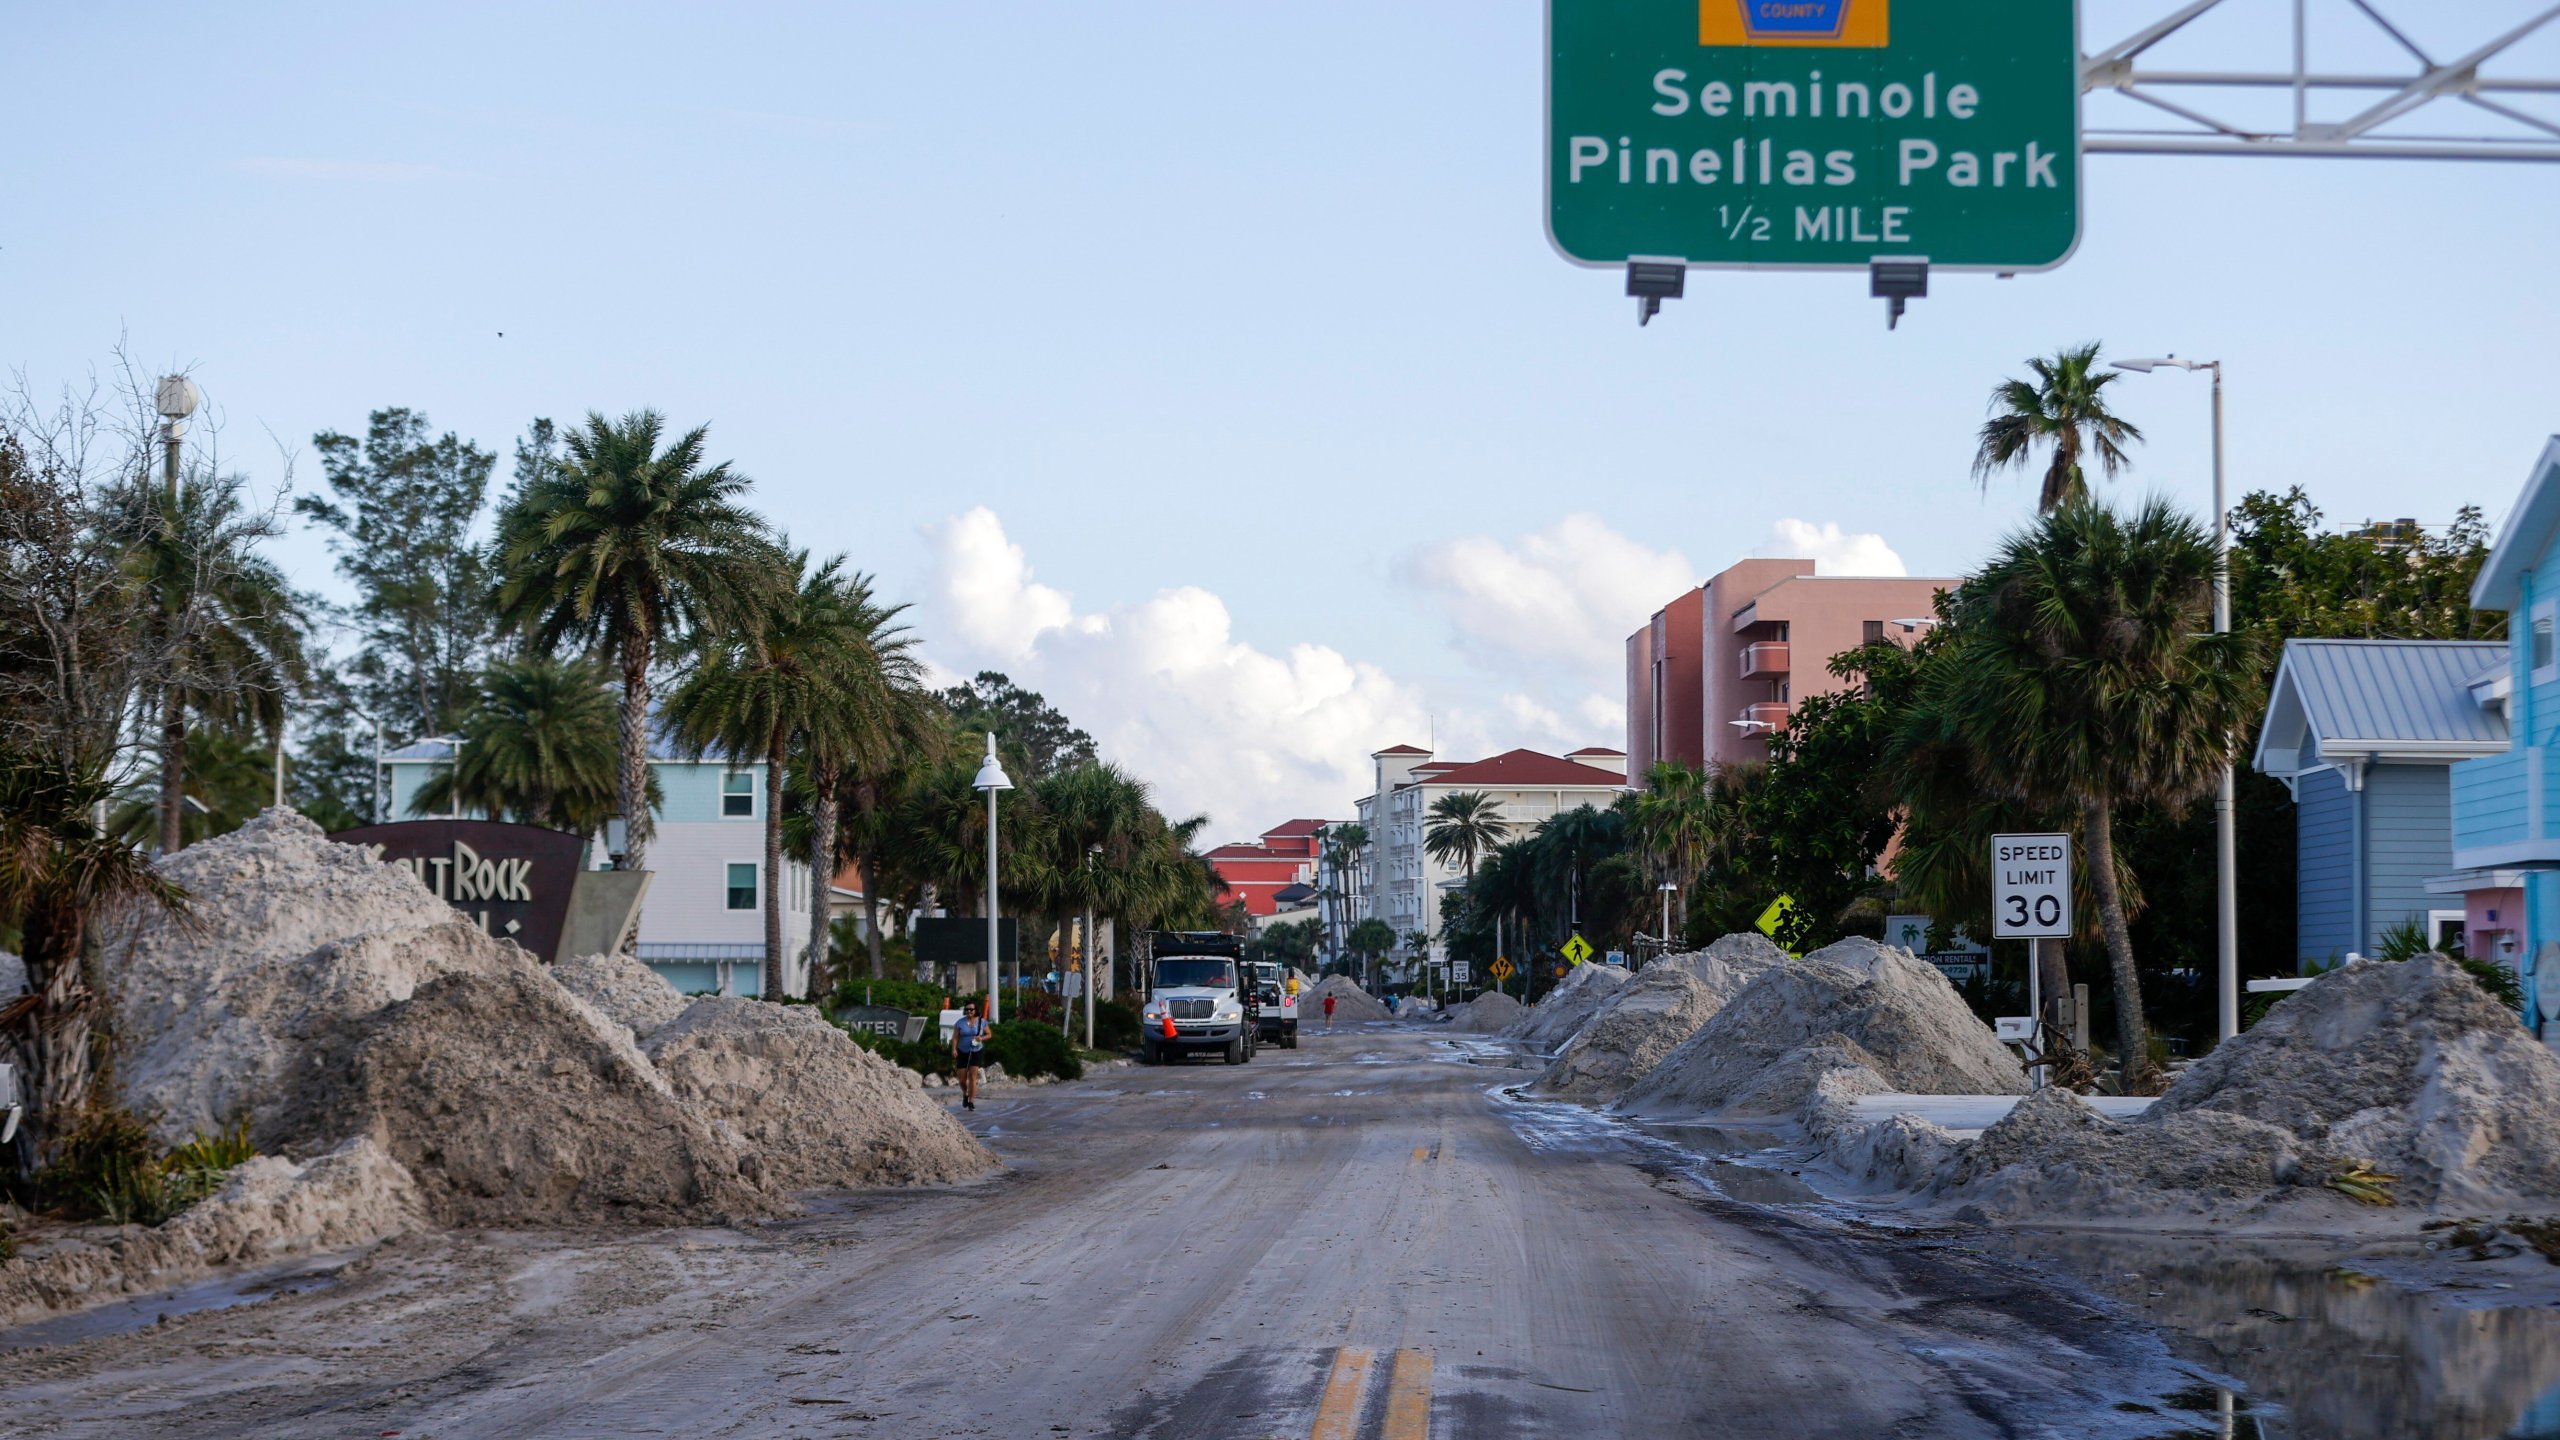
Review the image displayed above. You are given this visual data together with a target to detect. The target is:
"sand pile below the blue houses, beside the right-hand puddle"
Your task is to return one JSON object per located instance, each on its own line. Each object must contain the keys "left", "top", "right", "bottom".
{"left": 1928, "top": 956, "right": 2560, "bottom": 1217}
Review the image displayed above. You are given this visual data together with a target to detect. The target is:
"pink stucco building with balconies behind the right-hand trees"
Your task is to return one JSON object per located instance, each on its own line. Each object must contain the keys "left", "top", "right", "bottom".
{"left": 1626, "top": 559, "right": 1956, "bottom": 784}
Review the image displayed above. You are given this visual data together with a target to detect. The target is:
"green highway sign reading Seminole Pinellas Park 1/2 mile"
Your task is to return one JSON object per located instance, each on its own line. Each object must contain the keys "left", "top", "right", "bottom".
{"left": 1546, "top": 0, "right": 2079, "bottom": 272}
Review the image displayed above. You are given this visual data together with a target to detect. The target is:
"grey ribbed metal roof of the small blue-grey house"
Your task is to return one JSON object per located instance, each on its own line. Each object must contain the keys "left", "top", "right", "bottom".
{"left": 2255, "top": 641, "right": 2506, "bottom": 776}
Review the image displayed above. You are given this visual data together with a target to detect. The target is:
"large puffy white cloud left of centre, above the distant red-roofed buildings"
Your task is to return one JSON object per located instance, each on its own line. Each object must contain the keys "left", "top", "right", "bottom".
{"left": 919, "top": 507, "right": 1431, "bottom": 840}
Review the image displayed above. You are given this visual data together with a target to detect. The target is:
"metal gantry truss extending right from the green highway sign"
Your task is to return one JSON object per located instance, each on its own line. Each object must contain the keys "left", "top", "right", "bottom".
{"left": 2081, "top": 0, "right": 2560, "bottom": 161}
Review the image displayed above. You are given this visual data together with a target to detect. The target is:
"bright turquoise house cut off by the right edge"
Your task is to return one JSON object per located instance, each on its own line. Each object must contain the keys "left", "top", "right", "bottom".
{"left": 2445, "top": 436, "right": 2560, "bottom": 1040}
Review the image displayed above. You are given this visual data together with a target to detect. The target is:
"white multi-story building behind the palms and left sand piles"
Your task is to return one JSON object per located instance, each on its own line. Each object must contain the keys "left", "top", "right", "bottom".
{"left": 381, "top": 740, "right": 808, "bottom": 994}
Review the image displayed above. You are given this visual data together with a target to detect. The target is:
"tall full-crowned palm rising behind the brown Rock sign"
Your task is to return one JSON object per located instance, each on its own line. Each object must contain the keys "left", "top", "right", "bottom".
{"left": 497, "top": 410, "right": 773, "bottom": 871}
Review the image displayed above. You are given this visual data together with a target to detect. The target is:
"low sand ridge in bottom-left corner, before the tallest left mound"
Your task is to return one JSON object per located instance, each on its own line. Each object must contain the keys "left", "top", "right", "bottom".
{"left": 0, "top": 1140, "right": 425, "bottom": 1325}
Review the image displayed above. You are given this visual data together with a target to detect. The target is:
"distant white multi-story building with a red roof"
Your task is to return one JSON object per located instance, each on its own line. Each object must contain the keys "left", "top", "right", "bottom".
{"left": 1359, "top": 746, "right": 1626, "bottom": 961}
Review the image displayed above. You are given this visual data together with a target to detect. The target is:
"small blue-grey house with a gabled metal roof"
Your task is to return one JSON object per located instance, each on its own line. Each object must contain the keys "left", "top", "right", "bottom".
{"left": 2255, "top": 641, "right": 2506, "bottom": 961}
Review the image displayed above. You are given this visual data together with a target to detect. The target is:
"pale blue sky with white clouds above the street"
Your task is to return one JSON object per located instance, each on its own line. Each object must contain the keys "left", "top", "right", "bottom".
{"left": 0, "top": 0, "right": 2560, "bottom": 833}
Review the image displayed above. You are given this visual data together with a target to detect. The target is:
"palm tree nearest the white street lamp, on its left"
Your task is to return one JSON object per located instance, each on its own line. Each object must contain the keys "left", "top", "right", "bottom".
{"left": 799, "top": 571, "right": 947, "bottom": 994}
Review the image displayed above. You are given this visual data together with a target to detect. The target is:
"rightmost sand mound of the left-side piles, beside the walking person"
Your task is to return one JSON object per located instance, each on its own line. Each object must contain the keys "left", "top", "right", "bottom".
{"left": 648, "top": 997, "right": 996, "bottom": 1189}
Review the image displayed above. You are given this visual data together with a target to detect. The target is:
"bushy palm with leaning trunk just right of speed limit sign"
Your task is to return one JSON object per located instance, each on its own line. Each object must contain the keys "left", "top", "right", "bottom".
{"left": 1920, "top": 500, "right": 2260, "bottom": 1092}
